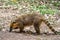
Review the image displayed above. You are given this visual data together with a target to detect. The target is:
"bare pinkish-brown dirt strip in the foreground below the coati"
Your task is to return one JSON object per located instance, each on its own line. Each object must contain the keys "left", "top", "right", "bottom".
{"left": 0, "top": 31, "right": 60, "bottom": 40}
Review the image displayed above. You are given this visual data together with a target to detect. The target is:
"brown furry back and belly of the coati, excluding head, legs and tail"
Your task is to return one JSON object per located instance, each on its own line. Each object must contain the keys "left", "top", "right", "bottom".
{"left": 15, "top": 13, "right": 44, "bottom": 26}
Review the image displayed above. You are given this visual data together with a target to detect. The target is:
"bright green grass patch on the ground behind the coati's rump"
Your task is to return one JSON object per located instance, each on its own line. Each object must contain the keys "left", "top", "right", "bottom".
{"left": 32, "top": 5, "right": 58, "bottom": 15}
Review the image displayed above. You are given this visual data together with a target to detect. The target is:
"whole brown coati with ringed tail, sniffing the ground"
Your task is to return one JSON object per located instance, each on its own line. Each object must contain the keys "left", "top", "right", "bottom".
{"left": 9, "top": 13, "right": 57, "bottom": 34}
